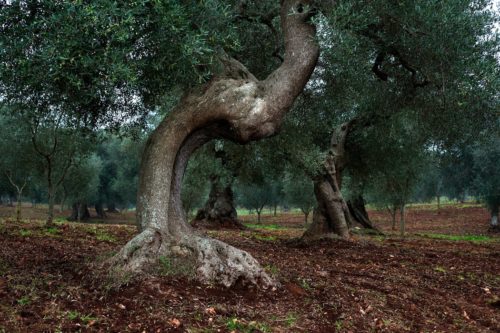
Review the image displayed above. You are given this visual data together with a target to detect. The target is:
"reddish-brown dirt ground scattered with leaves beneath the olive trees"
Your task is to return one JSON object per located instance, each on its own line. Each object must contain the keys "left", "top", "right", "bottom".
{"left": 0, "top": 206, "right": 500, "bottom": 333}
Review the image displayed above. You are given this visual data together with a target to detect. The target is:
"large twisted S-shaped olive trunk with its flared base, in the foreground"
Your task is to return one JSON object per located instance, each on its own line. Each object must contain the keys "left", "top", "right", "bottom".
{"left": 109, "top": 0, "right": 319, "bottom": 287}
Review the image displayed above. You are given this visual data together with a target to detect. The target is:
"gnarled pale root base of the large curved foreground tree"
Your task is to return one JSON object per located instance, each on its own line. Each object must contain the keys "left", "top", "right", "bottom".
{"left": 107, "top": 229, "right": 279, "bottom": 288}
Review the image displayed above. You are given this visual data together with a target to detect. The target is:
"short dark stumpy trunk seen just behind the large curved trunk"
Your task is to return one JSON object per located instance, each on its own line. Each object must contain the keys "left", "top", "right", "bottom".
{"left": 192, "top": 176, "right": 244, "bottom": 228}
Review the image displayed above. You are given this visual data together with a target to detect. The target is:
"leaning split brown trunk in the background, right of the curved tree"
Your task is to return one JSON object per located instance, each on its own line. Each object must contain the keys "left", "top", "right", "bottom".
{"left": 302, "top": 124, "right": 351, "bottom": 241}
